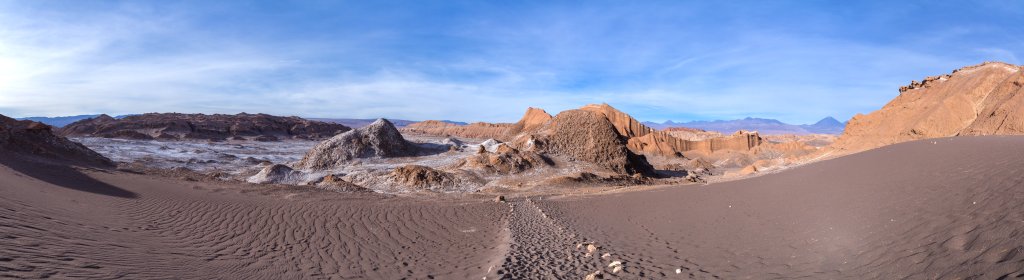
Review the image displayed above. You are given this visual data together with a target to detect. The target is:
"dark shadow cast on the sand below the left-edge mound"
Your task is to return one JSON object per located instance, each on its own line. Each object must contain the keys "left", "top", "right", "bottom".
{"left": 0, "top": 160, "right": 138, "bottom": 198}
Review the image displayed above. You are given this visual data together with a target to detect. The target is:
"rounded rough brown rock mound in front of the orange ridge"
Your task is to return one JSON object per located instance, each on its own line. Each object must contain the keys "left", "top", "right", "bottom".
{"left": 522, "top": 110, "right": 653, "bottom": 174}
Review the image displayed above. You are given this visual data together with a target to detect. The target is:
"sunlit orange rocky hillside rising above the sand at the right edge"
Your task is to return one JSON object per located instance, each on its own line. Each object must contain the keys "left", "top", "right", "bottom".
{"left": 834, "top": 63, "right": 1024, "bottom": 152}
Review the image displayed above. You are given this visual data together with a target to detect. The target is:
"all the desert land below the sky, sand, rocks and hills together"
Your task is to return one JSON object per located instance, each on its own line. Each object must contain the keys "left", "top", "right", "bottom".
{"left": 0, "top": 63, "right": 1024, "bottom": 279}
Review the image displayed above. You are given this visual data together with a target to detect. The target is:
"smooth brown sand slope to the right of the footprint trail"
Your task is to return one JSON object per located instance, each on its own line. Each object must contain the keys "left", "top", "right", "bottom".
{"left": 538, "top": 136, "right": 1024, "bottom": 279}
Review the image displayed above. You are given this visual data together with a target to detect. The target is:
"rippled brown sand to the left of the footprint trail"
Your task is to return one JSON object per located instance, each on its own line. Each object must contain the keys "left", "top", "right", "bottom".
{"left": 0, "top": 157, "right": 508, "bottom": 279}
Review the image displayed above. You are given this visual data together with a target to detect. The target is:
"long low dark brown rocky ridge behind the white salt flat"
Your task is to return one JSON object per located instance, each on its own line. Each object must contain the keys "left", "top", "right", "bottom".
{"left": 59, "top": 113, "right": 350, "bottom": 141}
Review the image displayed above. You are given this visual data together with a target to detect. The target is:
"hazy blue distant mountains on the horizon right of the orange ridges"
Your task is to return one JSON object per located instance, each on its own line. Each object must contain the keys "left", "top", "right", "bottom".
{"left": 643, "top": 117, "right": 846, "bottom": 134}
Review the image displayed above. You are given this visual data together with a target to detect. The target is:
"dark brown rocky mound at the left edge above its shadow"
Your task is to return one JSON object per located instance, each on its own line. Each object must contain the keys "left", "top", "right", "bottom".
{"left": 0, "top": 115, "right": 114, "bottom": 167}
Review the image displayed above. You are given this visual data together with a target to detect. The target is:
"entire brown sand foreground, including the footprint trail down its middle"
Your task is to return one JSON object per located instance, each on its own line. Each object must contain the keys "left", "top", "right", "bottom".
{"left": 0, "top": 136, "right": 1024, "bottom": 279}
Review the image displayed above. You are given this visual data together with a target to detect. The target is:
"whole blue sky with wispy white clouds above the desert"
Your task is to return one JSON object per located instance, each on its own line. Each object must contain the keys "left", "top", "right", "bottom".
{"left": 0, "top": 0, "right": 1024, "bottom": 123}
